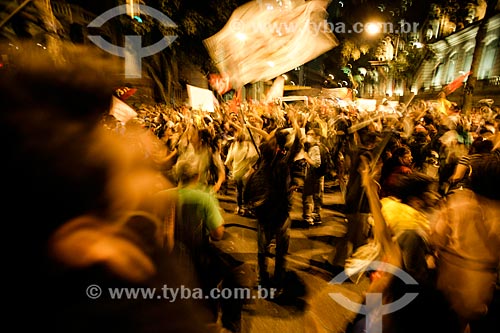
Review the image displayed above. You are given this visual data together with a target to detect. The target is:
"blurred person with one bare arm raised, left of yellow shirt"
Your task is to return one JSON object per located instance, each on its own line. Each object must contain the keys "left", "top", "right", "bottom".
{"left": 346, "top": 156, "right": 458, "bottom": 333}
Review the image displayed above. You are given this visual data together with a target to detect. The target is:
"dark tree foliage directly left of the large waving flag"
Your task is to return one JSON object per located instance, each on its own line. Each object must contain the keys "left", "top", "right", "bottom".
{"left": 116, "top": 0, "right": 248, "bottom": 103}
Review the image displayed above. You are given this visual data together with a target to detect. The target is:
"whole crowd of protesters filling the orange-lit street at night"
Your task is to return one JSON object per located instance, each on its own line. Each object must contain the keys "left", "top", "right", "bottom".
{"left": 4, "top": 42, "right": 500, "bottom": 333}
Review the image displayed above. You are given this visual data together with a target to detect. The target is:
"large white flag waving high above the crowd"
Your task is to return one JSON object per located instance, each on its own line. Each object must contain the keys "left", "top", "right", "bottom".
{"left": 204, "top": 0, "right": 338, "bottom": 87}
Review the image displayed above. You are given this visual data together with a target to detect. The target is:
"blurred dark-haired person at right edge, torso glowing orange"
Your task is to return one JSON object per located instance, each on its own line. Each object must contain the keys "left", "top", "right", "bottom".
{"left": 431, "top": 154, "right": 500, "bottom": 333}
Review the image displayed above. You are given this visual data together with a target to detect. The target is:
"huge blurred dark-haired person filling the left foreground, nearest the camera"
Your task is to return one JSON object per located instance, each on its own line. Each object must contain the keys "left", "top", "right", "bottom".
{"left": 0, "top": 45, "right": 206, "bottom": 333}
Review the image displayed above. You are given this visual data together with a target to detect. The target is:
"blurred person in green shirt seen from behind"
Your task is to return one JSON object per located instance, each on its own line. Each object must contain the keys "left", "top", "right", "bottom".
{"left": 155, "top": 160, "right": 243, "bottom": 332}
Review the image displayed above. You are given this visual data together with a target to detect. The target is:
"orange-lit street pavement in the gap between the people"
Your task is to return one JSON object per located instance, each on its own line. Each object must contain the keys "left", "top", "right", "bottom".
{"left": 213, "top": 180, "right": 368, "bottom": 333}
